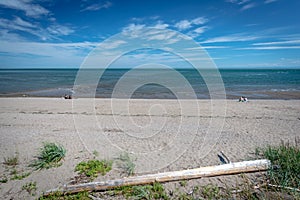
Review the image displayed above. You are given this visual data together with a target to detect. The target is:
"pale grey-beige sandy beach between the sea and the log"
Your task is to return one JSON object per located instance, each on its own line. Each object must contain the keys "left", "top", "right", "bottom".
{"left": 0, "top": 98, "right": 300, "bottom": 199}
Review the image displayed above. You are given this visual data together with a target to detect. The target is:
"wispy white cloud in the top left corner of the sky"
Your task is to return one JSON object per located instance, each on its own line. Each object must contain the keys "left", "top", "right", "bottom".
{"left": 0, "top": 0, "right": 50, "bottom": 17}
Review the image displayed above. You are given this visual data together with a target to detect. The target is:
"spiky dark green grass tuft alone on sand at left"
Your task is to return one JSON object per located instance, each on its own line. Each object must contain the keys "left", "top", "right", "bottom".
{"left": 29, "top": 143, "right": 66, "bottom": 170}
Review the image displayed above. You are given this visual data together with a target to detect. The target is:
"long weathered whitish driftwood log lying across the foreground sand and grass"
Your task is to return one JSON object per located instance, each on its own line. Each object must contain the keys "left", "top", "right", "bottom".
{"left": 44, "top": 159, "right": 271, "bottom": 196}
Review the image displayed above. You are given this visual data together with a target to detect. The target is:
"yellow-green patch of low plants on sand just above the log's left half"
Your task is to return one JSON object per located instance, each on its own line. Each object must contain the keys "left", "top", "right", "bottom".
{"left": 75, "top": 160, "right": 112, "bottom": 180}
